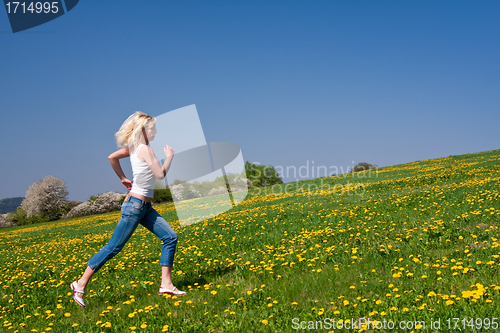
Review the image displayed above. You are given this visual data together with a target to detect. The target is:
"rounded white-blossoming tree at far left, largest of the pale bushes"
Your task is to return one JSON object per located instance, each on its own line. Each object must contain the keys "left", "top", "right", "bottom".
{"left": 21, "top": 175, "right": 68, "bottom": 219}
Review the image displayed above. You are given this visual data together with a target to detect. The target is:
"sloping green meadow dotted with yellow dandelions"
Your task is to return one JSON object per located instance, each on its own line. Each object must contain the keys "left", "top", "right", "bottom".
{"left": 0, "top": 150, "right": 500, "bottom": 333}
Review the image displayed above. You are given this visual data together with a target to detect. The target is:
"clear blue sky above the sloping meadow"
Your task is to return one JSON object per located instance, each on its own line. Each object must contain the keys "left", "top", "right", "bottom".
{"left": 0, "top": 0, "right": 500, "bottom": 201}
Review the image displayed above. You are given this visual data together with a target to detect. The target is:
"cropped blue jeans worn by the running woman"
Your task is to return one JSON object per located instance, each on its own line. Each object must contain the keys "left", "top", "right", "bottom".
{"left": 87, "top": 196, "right": 177, "bottom": 273}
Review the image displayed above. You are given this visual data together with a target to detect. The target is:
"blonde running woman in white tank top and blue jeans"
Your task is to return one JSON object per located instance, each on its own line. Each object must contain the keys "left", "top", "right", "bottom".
{"left": 71, "top": 111, "right": 186, "bottom": 307}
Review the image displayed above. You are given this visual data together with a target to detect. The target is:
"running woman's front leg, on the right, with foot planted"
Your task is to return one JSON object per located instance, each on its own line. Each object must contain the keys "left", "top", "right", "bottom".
{"left": 141, "top": 207, "right": 178, "bottom": 290}
